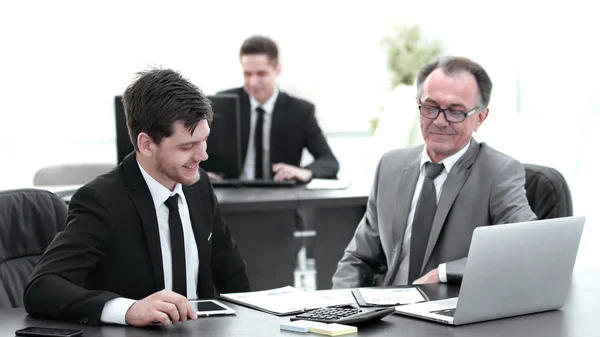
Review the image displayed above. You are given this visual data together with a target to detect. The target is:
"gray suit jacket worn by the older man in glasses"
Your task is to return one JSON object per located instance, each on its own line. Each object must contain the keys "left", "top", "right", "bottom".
{"left": 333, "top": 139, "right": 535, "bottom": 288}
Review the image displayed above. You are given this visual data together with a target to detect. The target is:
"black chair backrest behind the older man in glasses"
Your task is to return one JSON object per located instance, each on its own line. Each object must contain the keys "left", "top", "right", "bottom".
{"left": 523, "top": 164, "right": 573, "bottom": 219}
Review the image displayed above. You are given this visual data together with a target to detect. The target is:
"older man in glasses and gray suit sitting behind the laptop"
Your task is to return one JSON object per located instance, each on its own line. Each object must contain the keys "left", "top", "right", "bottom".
{"left": 333, "top": 57, "right": 535, "bottom": 288}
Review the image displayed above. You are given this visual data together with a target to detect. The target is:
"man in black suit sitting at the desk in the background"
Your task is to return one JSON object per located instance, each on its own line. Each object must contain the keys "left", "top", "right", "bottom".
{"left": 211, "top": 36, "right": 339, "bottom": 182}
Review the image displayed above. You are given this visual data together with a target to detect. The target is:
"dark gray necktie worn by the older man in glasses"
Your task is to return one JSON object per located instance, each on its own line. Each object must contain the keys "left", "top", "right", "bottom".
{"left": 408, "top": 162, "right": 444, "bottom": 284}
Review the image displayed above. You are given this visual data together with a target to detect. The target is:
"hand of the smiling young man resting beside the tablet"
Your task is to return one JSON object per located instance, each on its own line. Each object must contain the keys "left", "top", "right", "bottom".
{"left": 125, "top": 289, "right": 198, "bottom": 326}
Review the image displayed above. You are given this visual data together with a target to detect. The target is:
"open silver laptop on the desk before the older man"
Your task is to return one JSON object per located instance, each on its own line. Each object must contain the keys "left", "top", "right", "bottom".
{"left": 396, "top": 216, "right": 585, "bottom": 325}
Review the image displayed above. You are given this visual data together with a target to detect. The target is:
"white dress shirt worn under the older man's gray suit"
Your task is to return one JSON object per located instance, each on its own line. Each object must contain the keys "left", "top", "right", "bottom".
{"left": 400, "top": 142, "right": 471, "bottom": 284}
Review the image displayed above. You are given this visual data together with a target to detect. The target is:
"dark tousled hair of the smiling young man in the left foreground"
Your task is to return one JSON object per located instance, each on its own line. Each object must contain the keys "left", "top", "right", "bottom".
{"left": 123, "top": 69, "right": 213, "bottom": 151}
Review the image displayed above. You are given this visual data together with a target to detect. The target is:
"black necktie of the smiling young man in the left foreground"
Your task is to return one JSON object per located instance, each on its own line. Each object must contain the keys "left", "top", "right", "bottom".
{"left": 165, "top": 194, "right": 187, "bottom": 297}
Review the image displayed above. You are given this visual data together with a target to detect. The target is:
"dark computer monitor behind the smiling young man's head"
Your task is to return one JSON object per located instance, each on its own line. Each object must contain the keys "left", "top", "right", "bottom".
{"left": 115, "top": 94, "right": 242, "bottom": 179}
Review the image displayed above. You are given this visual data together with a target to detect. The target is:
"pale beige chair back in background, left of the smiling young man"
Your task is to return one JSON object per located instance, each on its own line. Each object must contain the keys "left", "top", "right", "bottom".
{"left": 33, "top": 164, "right": 115, "bottom": 186}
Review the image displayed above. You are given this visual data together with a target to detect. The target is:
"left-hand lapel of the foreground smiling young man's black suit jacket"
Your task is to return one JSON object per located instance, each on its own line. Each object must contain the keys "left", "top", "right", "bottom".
{"left": 123, "top": 152, "right": 165, "bottom": 290}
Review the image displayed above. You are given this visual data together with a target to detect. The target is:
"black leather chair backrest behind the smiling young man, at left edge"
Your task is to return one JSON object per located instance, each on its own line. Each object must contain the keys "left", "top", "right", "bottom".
{"left": 0, "top": 189, "right": 67, "bottom": 308}
